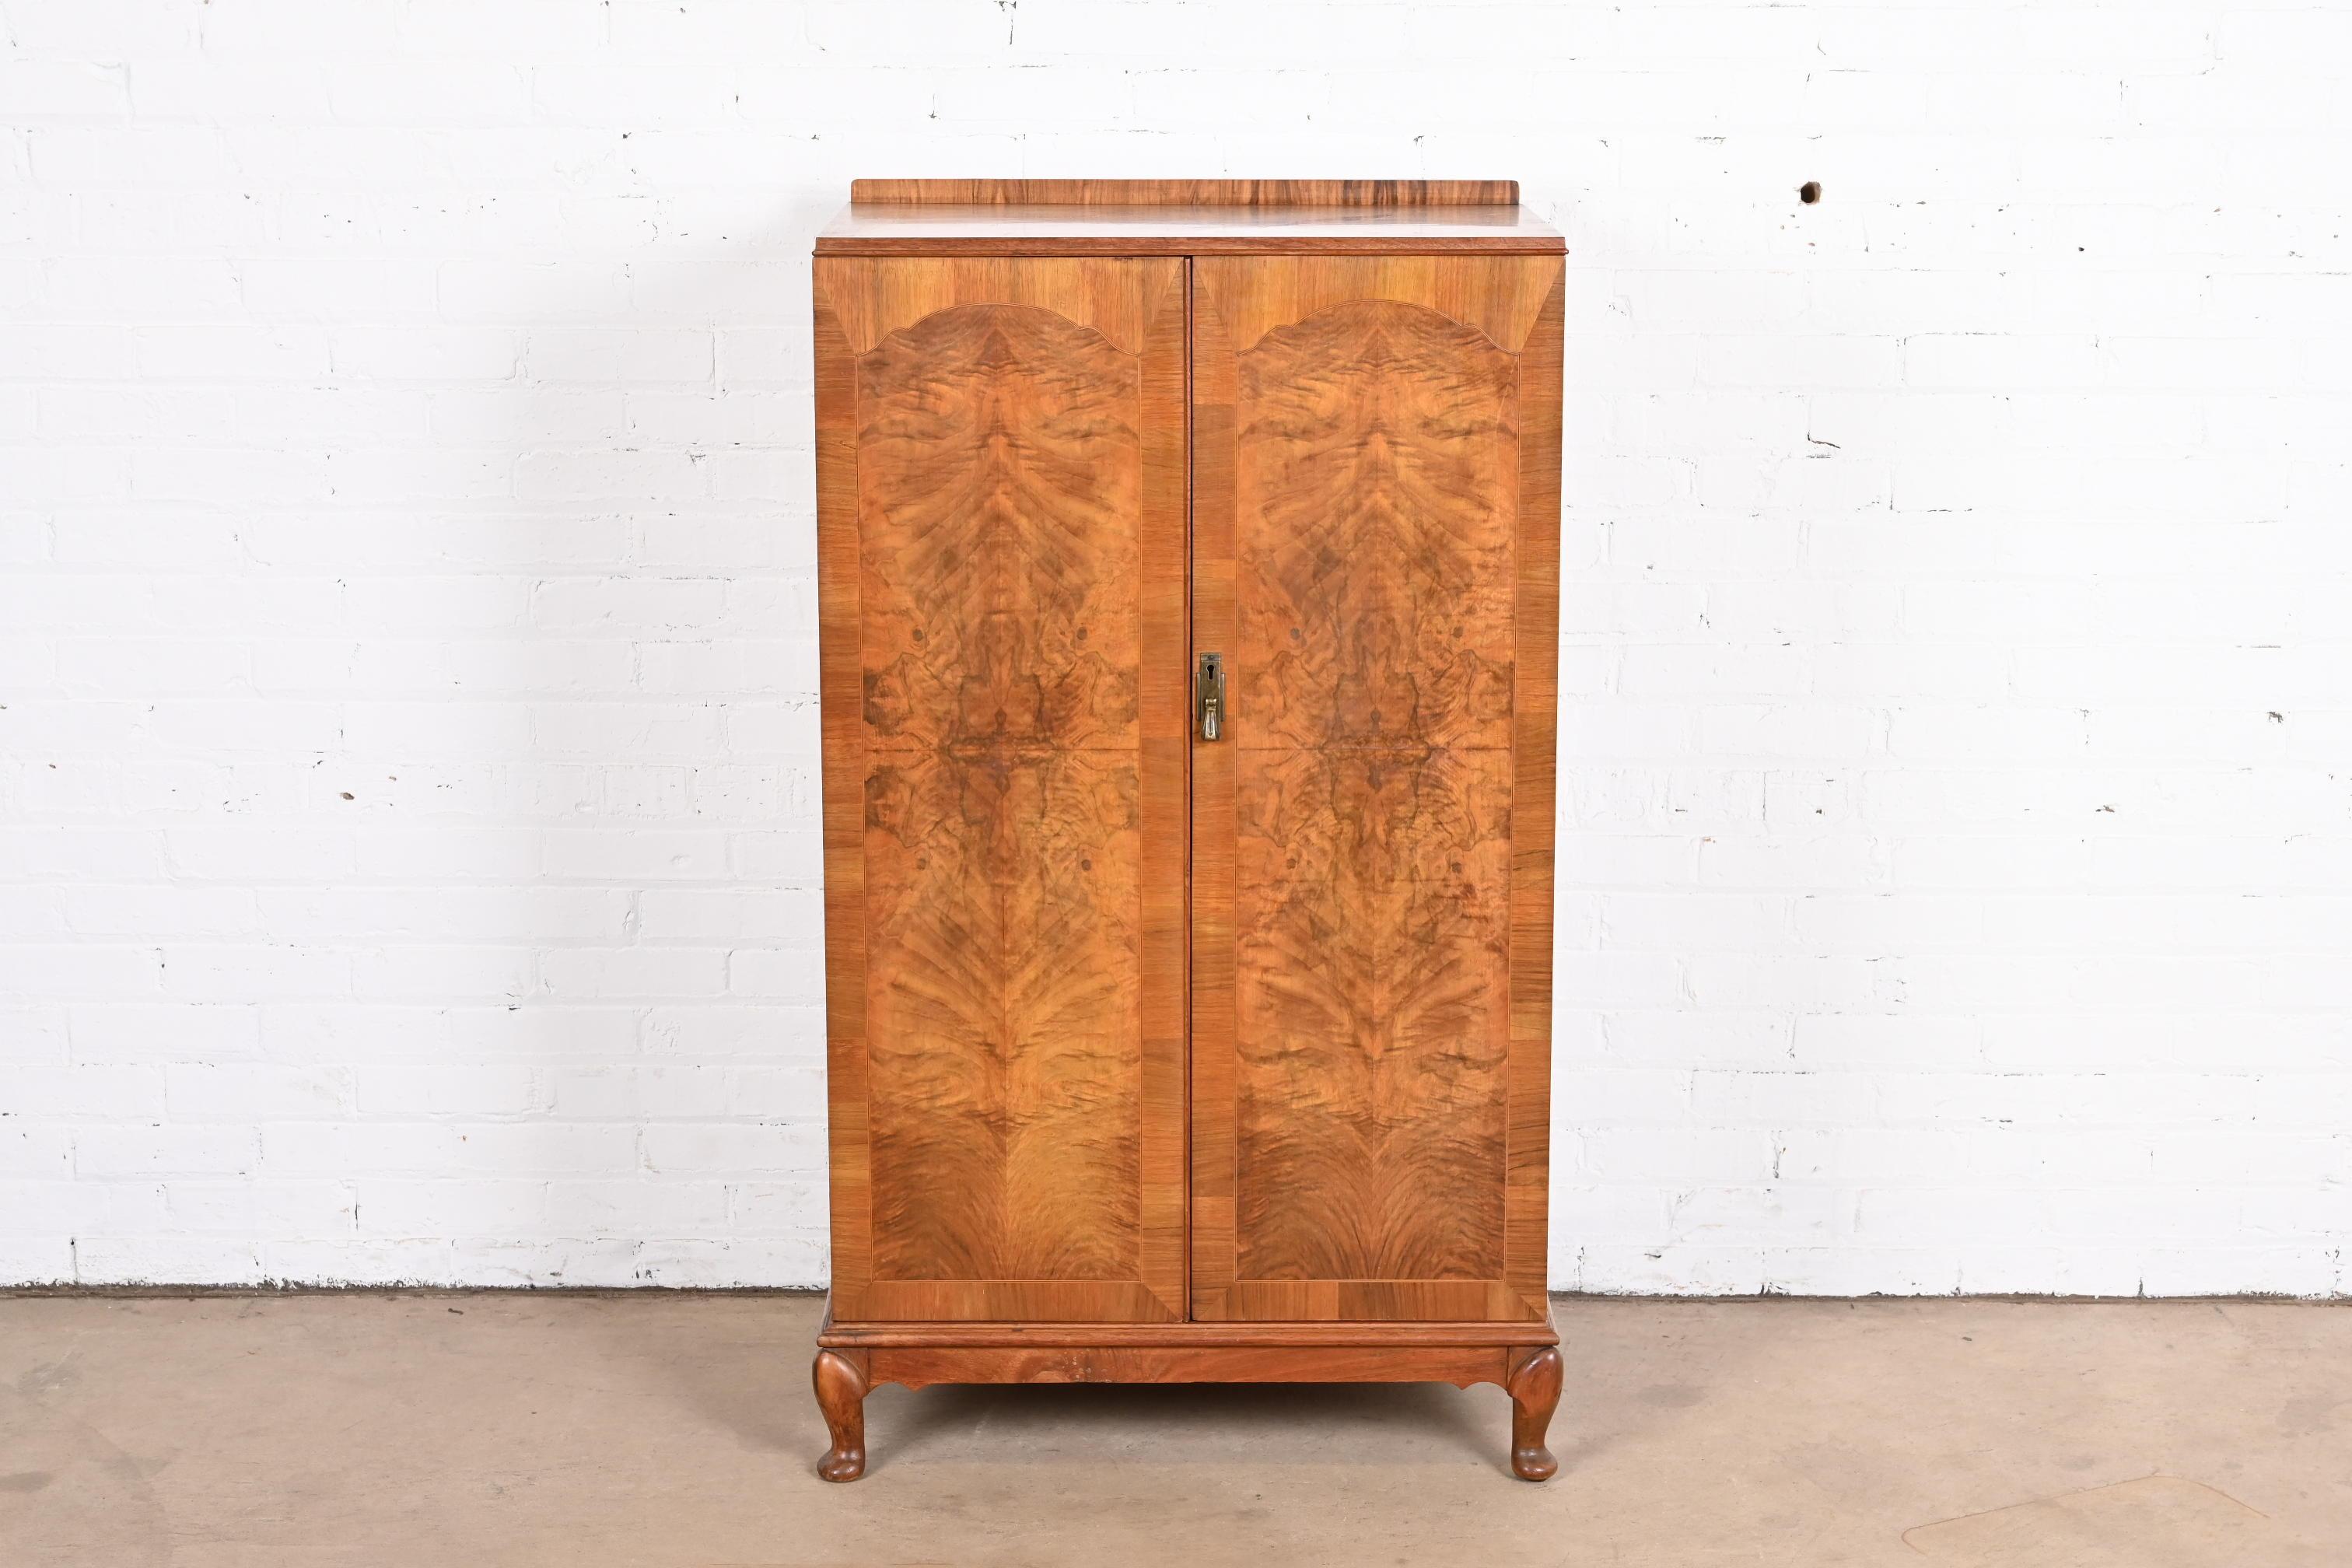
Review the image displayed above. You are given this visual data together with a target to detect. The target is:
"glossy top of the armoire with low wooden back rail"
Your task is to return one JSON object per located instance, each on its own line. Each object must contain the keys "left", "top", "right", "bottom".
{"left": 816, "top": 181, "right": 1566, "bottom": 256}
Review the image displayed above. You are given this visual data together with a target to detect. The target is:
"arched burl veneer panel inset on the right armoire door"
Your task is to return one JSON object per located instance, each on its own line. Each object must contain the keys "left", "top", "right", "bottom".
{"left": 1233, "top": 272, "right": 1517, "bottom": 1314}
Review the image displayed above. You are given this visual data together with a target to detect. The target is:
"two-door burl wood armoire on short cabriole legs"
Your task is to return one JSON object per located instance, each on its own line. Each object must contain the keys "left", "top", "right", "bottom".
{"left": 814, "top": 181, "right": 1566, "bottom": 1481}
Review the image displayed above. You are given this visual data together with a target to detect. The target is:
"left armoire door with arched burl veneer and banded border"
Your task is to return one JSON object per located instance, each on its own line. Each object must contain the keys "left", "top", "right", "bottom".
{"left": 814, "top": 256, "right": 1190, "bottom": 1324}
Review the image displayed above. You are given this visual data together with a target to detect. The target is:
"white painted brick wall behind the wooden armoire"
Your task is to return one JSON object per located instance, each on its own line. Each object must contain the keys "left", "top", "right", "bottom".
{"left": 0, "top": 0, "right": 2352, "bottom": 1295}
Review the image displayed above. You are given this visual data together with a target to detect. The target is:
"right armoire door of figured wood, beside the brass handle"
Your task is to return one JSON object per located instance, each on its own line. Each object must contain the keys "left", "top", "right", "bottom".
{"left": 1192, "top": 256, "right": 1562, "bottom": 1321}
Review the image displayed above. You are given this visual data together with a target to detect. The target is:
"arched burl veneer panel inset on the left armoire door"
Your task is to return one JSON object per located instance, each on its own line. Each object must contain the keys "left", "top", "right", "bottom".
{"left": 859, "top": 303, "right": 1143, "bottom": 1281}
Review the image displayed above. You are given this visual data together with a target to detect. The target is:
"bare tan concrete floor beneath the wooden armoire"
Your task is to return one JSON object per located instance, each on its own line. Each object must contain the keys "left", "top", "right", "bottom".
{"left": 0, "top": 1293, "right": 2352, "bottom": 1568}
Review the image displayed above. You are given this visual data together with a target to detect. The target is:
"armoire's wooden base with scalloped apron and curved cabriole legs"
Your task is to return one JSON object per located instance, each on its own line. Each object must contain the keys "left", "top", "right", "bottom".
{"left": 811, "top": 1310, "right": 1559, "bottom": 1481}
